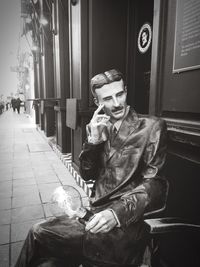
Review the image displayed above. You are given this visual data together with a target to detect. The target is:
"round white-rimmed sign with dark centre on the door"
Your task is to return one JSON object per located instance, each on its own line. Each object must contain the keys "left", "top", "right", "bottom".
{"left": 138, "top": 23, "right": 152, "bottom": 53}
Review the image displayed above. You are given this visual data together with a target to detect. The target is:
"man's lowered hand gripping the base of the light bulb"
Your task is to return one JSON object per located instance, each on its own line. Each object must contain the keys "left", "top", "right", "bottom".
{"left": 85, "top": 210, "right": 117, "bottom": 234}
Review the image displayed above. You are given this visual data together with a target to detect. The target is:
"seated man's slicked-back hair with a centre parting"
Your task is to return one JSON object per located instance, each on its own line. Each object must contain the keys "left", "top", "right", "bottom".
{"left": 90, "top": 69, "right": 124, "bottom": 96}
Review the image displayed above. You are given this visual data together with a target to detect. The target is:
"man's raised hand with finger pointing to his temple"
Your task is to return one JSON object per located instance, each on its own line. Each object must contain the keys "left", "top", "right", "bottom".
{"left": 86, "top": 104, "right": 110, "bottom": 143}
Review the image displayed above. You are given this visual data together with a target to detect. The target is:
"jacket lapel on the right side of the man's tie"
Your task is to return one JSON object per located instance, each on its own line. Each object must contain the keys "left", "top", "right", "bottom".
{"left": 107, "top": 109, "right": 139, "bottom": 161}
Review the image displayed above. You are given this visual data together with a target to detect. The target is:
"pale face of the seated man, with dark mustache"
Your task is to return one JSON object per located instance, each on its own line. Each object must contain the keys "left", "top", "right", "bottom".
{"left": 95, "top": 80, "right": 127, "bottom": 122}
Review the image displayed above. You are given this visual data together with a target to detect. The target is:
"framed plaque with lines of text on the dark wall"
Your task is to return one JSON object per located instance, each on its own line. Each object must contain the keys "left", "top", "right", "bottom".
{"left": 173, "top": 0, "right": 200, "bottom": 73}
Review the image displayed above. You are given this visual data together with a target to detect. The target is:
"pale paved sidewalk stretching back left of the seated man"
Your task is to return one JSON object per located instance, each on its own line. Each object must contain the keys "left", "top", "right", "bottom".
{"left": 0, "top": 109, "right": 87, "bottom": 267}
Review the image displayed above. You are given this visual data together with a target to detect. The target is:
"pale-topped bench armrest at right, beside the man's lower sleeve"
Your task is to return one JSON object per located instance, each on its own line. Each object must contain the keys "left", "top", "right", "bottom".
{"left": 144, "top": 217, "right": 200, "bottom": 234}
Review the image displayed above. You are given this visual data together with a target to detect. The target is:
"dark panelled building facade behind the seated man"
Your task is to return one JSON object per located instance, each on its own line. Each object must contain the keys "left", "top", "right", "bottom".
{"left": 22, "top": 0, "right": 200, "bottom": 266}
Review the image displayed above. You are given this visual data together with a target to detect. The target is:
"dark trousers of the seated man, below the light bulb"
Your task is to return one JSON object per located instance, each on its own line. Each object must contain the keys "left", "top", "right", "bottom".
{"left": 15, "top": 216, "right": 146, "bottom": 267}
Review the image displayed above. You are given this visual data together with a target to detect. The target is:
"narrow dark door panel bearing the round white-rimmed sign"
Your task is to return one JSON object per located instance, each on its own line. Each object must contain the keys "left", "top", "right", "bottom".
{"left": 127, "top": 0, "right": 154, "bottom": 114}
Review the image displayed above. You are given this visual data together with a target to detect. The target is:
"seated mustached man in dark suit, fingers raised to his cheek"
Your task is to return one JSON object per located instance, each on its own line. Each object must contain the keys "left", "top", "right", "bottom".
{"left": 15, "top": 69, "right": 166, "bottom": 267}
